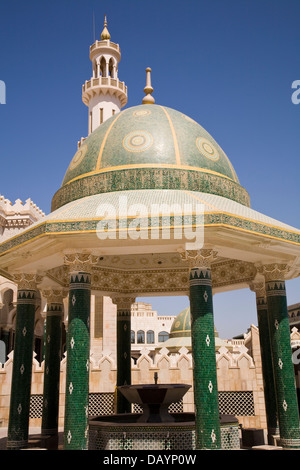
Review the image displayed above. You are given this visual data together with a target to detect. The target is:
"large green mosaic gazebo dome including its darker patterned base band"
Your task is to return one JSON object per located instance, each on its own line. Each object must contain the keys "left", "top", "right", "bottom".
{"left": 52, "top": 104, "right": 250, "bottom": 210}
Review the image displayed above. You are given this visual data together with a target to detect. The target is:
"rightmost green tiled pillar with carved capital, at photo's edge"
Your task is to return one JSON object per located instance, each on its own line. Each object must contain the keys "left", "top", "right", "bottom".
{"left": 259, "top": 264, "right": 300, "bottom": 449}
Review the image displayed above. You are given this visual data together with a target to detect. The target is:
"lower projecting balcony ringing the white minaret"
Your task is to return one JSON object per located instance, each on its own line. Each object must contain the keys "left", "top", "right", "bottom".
{"left": 82, "top": 76, "right": 127, "bottom": 107}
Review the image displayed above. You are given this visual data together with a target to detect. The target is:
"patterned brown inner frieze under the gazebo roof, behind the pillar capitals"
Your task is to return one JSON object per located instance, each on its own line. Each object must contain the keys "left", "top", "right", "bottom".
{"left": 47, "top": 255, "right": 257, "bottom": 297}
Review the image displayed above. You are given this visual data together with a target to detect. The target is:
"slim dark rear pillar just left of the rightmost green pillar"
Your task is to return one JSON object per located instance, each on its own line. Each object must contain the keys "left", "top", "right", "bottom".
{"left": 250, "top": 280, "right": 279, "bottom": 445}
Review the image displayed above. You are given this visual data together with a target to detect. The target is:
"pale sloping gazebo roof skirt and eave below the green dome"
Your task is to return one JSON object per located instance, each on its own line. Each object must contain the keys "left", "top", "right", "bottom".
{"left": 0, "top": 190, "right": 300, "bottom": 284}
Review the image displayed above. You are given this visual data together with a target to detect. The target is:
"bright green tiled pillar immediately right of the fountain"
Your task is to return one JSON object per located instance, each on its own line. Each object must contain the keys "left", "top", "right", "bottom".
{"left": 182, "top": 249, "right": 221, "bottom": 449}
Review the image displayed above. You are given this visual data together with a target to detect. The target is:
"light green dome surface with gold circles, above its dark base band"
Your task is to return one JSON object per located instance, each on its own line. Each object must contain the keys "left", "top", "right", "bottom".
{"left": 63, "top": 105, "right": 238, "bottom": 185}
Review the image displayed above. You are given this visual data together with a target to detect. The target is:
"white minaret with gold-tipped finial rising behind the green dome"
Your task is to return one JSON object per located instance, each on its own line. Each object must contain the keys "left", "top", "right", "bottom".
{"left": 82, "top": 15, "right": 127, "bottom": 134}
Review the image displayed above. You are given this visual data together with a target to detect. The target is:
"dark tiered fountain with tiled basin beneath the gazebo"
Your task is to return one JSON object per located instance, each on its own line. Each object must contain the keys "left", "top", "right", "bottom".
{"left": 89, "top": 373, "right": 239, "bottom": 450}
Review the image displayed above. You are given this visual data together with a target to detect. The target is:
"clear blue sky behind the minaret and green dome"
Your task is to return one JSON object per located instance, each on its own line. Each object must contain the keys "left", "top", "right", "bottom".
{"left": 0, "top": 0, "right": 300, "bottom": 337}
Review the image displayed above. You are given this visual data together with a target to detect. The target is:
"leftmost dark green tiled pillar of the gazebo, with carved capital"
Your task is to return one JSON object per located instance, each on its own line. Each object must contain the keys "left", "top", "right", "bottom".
{"left": 7, "top": 273, "right": 42, "bottom": 450}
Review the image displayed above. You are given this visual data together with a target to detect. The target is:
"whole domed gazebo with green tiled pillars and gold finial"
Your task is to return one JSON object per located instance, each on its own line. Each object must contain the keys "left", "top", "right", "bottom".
{"left": 0, "top": 23, "right": 300, "bottom": 449}
